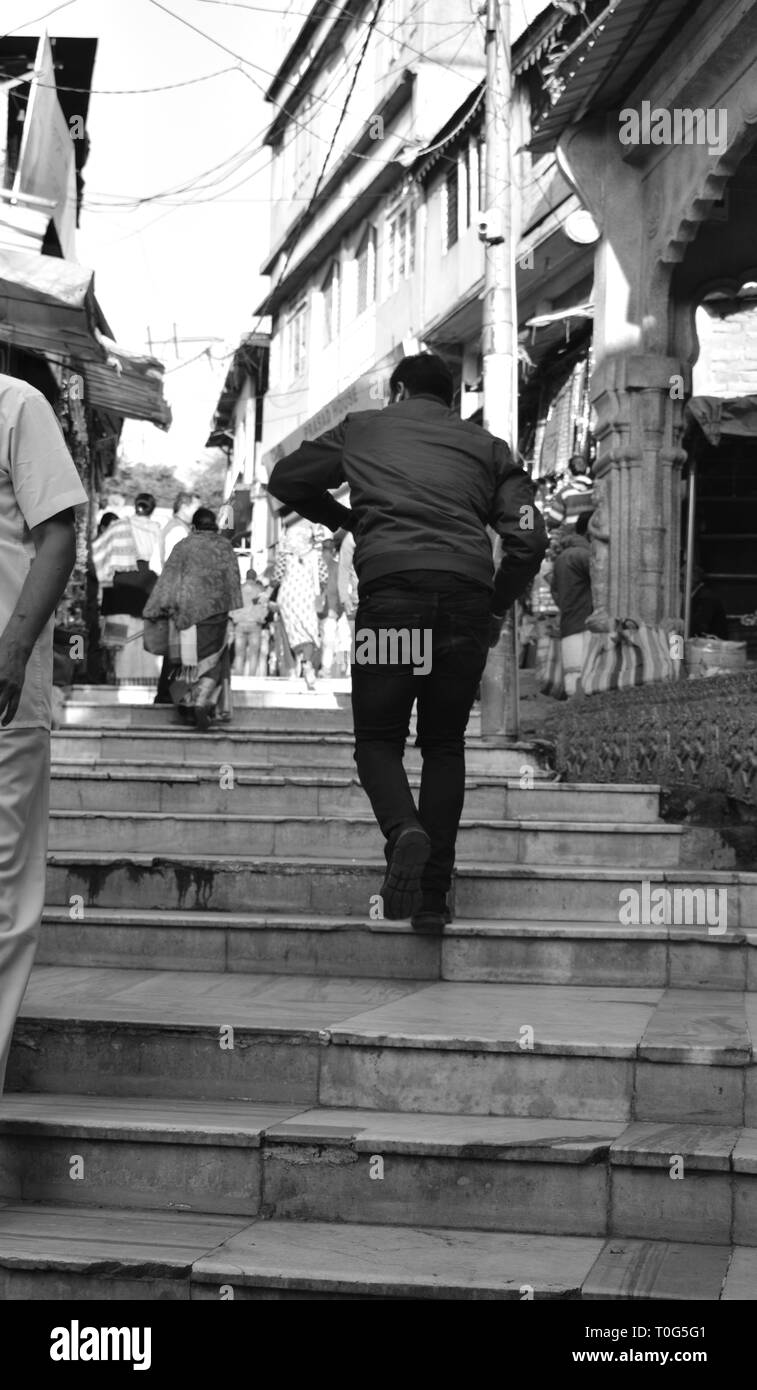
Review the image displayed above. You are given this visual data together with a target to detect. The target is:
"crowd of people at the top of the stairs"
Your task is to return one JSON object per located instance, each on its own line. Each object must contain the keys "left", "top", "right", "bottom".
{"left": 90, "top": 491, "right": 357, "bottom": 727}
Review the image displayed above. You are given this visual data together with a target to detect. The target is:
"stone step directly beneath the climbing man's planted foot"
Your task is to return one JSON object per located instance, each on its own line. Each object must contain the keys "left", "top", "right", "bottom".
{"left": 36, "top": 906, "right": 757, "bottom": 991}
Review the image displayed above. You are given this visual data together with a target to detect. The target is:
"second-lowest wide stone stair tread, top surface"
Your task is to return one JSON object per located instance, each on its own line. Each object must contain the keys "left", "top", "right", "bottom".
{"left": 0, "top": 1091, "right": 757, "bottom": 1176}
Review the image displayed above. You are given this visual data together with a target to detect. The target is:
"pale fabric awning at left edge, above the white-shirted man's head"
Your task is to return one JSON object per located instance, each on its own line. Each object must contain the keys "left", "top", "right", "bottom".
{"left": 0, "top": 247, "right": 97, "bottom": 360}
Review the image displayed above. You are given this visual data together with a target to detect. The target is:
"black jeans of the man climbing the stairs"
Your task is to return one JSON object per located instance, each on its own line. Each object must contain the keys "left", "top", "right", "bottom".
{"left": 351, "top": 570, "right": 492, "bottom": 892}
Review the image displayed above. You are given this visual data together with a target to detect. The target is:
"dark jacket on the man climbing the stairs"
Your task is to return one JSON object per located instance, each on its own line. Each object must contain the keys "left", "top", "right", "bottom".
{"left": 268, "top": 396, "right": 547, "bottom": 613}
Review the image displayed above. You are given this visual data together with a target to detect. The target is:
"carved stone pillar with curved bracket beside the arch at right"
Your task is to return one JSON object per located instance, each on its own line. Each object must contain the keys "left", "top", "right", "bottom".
{"left": 560, "top": 117, "right": 688, "bottom": 624}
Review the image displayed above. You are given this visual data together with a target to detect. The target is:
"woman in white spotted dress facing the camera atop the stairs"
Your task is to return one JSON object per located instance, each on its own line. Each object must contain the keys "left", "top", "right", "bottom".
{"left": 274, "top": 524, "right": 328, "bottom": 689}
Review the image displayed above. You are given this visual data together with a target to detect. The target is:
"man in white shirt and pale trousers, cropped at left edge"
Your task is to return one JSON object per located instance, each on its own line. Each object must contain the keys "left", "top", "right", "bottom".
{"left": 0, "top": 374, "right": 88, "bottom": 1093}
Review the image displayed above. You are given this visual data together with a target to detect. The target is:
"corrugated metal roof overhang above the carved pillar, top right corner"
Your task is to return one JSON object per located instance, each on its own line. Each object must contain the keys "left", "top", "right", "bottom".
{"left": 531, "top": 0, "right": 699, "bottom": 150}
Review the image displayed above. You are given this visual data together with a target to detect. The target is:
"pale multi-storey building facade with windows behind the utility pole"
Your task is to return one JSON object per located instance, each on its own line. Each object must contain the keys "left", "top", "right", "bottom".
{"left": 260, "top": 3, "right": 593, "bottom": 505}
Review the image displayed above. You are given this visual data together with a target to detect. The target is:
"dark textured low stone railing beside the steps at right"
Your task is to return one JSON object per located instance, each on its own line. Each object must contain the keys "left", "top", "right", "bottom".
{"left": 542, "top": 670, "right": 757, "bottom": 805}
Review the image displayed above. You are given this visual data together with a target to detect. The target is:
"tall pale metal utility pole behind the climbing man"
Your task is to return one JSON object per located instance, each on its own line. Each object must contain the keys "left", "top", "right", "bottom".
{"left": 481, "top": 0, "right": 518, "bottom": 738}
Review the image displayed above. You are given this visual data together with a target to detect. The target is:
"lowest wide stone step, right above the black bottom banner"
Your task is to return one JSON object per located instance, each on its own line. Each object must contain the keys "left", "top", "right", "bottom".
{"left": 0, "top": 1202, "right": 757, "bottom": 1295}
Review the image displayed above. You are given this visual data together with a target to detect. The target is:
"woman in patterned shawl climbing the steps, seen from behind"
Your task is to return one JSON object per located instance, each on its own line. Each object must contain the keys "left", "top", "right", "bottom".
{"left": 144, "top": 507, "right": 242, "bottom": 730}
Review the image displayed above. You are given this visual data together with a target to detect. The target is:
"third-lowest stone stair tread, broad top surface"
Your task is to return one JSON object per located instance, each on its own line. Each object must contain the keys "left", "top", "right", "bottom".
{"left": 21, "top": 966, "right": 757, "bottom": 1066}
